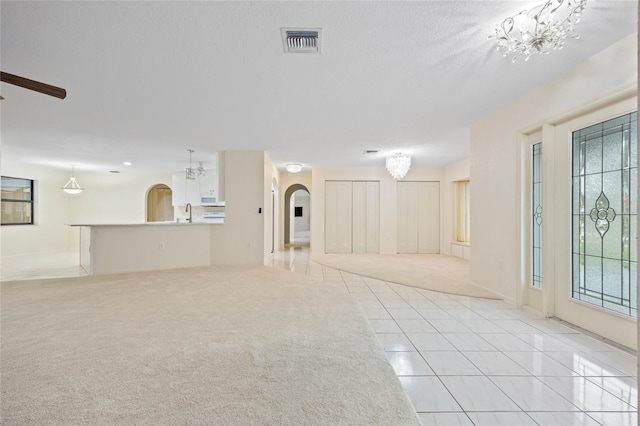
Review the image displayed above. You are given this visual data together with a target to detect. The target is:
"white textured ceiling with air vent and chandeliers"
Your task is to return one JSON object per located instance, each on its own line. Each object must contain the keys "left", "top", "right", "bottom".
{"left": 0, "top": 0, "right": 638, "bottom": 172}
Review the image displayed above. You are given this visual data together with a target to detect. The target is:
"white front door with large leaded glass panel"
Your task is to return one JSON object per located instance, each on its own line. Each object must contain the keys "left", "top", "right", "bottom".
{"left": 544, "top": 98, "right": 637, "bottom": 348}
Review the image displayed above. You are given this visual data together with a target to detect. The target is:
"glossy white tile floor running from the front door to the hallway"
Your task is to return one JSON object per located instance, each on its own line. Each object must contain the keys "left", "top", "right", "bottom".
{"left": 271, "top": 248, "right": 638, "bottom": 426}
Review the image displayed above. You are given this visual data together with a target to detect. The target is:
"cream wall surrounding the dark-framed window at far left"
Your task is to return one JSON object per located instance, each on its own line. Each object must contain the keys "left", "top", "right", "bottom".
{"left": 0, "top": 161, "right": 75, "bottom": 256}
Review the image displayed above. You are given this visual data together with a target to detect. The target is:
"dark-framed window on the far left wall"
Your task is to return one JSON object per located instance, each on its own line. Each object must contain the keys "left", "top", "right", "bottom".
{"left": 0, "top": 176, "right": 33, "bottom": 225}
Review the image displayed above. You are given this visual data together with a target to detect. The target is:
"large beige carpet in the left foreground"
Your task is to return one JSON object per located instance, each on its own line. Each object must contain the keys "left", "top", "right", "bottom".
{"left": 0, "top": 267, "right": 420, "bottom": 425}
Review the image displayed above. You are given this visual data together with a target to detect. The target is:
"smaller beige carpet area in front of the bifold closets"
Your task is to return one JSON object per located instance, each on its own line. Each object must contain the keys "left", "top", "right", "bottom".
{"left": 311, "top": 253, "right": 502, "bottom": 299}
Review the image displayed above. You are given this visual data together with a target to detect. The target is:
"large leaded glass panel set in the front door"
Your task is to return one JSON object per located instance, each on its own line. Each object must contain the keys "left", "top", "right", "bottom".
{"left": 572, "top": 112, "right": 638, "bottom": 317}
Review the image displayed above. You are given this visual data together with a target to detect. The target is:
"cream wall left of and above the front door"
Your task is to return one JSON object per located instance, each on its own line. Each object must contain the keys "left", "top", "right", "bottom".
{"left": 470, "top": 34, "right": 637, "bottom": 300}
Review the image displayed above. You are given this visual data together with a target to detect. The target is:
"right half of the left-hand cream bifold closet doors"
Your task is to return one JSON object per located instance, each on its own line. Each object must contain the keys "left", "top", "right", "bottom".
{"left": 352, "top": 181, "right": 380, "bottom": 253}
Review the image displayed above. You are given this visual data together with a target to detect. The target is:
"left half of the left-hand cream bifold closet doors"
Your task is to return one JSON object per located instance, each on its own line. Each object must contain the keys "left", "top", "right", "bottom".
{"left": 324, "top": 181, "right": 352, "bottom": 253}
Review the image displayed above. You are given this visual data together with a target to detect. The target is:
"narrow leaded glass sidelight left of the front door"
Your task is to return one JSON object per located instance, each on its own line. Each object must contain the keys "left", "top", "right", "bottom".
{"left": 531, "top": 142, "right": 542, "bottom": 288}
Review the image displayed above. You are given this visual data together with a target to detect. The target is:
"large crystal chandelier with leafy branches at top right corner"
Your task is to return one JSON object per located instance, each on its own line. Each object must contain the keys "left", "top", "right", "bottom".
{"left": 489, "top": 0, "right": 587, "bottom": 62}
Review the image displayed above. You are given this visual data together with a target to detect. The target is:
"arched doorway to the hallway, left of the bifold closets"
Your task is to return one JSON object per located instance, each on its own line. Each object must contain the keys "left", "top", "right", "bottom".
{"left": 284, "top": 184, "right": 311, "bottom": 246}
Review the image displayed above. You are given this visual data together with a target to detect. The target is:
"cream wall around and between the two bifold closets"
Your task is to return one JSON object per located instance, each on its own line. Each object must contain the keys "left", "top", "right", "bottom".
{"left": 311, "top": 167, "right": 444, "bottom": 254}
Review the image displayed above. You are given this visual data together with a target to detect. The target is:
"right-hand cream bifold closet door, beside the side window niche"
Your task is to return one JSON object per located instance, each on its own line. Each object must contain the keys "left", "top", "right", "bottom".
{"left": 397, "top": 182, "right": 440, "bottom": 254}
